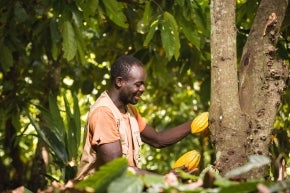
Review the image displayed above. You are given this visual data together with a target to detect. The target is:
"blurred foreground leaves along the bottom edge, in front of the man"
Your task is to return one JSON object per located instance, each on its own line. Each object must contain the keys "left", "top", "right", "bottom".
{"left": 58, "top": 156, "right": 276, "bottom": 193}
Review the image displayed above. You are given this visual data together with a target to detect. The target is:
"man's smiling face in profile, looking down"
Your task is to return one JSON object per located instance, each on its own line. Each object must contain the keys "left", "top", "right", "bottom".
{"left": 120, "top": 65, "right": 146, "bottom": 105}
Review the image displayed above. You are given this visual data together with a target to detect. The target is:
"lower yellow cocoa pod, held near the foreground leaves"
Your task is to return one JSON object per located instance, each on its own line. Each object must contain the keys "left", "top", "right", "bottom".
{"left": 172, "top": 150, "right": 200, "bottom": 172}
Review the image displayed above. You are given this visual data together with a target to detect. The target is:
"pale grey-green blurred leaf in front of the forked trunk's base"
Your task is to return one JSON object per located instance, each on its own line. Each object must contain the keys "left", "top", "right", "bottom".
{"left": 225, "top": 155, "right": 270, "bottom": 178}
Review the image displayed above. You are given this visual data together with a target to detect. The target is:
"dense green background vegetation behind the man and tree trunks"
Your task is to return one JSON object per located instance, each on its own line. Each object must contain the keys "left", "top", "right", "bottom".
{"left": 0, "top": 0, "right": 290, "bottom": 191}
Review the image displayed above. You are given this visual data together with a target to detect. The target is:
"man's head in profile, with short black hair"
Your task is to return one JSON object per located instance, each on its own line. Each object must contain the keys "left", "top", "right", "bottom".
{"left": 111, "top": 56, "right": 146, "bottom": 105}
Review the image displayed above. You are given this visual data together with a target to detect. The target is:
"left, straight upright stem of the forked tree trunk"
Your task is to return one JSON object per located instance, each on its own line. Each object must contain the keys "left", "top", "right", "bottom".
{"left": 210, "top": 0, "right": 247, "bottom": 179}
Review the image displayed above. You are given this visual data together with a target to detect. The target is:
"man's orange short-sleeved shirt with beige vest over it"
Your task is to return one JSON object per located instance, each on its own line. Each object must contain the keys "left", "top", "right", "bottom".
{"left": 75, "top": 92, "right": 146, "bottom": 181}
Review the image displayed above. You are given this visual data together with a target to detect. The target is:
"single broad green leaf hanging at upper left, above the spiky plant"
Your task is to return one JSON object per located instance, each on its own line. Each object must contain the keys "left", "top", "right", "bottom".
{"left": 61, "top": 21, "right": 77, "bottom": 61}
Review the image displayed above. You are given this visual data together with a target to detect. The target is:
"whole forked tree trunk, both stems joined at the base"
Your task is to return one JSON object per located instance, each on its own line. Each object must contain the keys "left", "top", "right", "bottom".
{"left": 210, "top": 0, "right": 288, "bottom": 179}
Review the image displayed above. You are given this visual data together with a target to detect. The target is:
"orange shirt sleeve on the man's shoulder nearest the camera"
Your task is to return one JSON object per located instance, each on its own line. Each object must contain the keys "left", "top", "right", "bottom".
{"left": 89, "top": 107, "right": 120, "bottom": 146}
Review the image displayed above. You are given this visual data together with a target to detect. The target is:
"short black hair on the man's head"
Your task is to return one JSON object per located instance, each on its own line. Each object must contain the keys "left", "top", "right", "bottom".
{"left": 111, "top": 55, "right": 144, "bottom": 83}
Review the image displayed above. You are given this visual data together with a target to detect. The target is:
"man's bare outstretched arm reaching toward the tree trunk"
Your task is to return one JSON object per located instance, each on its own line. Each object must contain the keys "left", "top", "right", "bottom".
{"left": 141, "top": 121, "right": 192, "bottom": 148}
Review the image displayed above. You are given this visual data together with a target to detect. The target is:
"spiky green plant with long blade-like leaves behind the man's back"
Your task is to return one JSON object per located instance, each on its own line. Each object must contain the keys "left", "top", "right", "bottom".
{"left": 28, "top": 91, "right": 81, "bottom": 182}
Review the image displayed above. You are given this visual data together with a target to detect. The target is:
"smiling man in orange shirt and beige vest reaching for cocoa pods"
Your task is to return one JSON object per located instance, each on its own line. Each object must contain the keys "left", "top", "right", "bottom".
{"left": 76, "top": 56, "right": 198, "bottom": 180}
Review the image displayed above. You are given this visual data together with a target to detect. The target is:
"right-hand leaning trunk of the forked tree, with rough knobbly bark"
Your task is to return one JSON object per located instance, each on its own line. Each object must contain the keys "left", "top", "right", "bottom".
{"left": 239, "top": 0, "right": 288, "bottom": 178}
